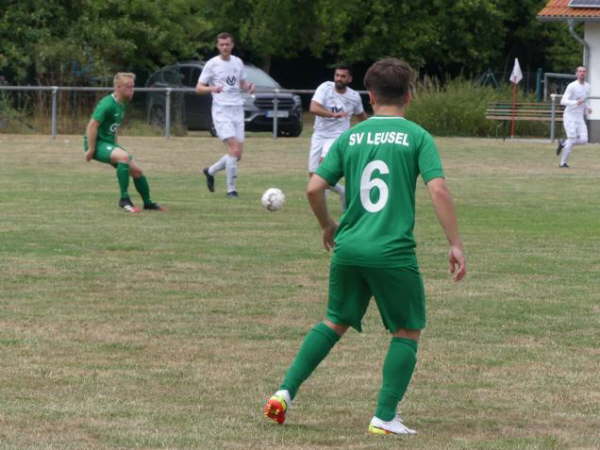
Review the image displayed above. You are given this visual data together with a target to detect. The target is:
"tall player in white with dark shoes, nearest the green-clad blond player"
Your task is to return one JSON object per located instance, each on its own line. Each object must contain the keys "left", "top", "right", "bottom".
{"left": 196, "top": 33, "right": 254, "bottom": 198}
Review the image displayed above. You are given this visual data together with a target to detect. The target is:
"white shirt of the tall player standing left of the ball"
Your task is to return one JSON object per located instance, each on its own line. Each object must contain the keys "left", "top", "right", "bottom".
{"left": 198, "top": 55, "right": 246, "bottom": 106}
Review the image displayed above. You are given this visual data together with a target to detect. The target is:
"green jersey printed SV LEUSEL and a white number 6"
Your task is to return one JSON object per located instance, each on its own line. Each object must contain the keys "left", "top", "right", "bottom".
{"left": 316, "top": 116, "right": 444, "bottom": 267}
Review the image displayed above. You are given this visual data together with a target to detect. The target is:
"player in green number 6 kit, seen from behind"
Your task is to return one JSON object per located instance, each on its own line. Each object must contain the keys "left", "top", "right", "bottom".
{"left": 264, "top": 58, "right": 466, "bottom": 434}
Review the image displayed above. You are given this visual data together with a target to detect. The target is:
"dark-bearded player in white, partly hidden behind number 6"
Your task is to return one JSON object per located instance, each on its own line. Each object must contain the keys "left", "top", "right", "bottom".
{"left": 308, "top": 65, "right": 367, "bottom": 207}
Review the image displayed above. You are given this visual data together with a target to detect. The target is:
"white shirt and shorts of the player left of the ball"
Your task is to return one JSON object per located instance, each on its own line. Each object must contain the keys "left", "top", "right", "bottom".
{"left": 198, "top": 55, "right": 246, "bottom": 142}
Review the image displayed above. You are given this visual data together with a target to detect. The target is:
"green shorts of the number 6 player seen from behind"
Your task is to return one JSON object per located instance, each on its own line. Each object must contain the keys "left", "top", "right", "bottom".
{"left": 327, "top": 263, "right": 426, "bottom": 333}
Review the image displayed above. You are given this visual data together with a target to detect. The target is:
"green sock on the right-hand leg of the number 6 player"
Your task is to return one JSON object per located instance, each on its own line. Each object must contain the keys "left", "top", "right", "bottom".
{"left": 375, "top": 337, "right": 417, "bottom": 422}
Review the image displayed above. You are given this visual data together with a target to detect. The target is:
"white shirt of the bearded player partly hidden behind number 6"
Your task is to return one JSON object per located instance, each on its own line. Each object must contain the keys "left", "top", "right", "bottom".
{"left": 312, "top": 81, "right": 364, "bottom": 138}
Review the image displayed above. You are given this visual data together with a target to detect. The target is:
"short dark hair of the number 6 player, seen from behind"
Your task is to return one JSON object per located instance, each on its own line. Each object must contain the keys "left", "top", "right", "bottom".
{"left": 363, "top": 58, "right": 415, "bottom": 106}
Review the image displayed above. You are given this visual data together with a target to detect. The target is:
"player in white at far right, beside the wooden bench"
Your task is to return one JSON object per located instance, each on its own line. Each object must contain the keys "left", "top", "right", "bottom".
{"left": 556, "top": 66, "right": 592, "bottom": 168}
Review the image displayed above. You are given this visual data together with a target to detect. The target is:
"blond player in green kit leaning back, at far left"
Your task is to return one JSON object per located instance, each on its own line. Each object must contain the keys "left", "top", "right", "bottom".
{"left": 83, "top": 72, "right": 165, "bottom": 213}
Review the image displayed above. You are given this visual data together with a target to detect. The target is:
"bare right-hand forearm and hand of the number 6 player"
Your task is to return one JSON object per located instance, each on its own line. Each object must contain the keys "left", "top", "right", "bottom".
{"left": 427, "top": 178, "right": 467, "bottom": 281}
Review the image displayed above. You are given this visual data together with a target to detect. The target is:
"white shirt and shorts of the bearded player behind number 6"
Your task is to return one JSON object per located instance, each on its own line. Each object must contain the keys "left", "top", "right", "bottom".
{"left": 308, "top": 81, "right": 364, "bottom": 173}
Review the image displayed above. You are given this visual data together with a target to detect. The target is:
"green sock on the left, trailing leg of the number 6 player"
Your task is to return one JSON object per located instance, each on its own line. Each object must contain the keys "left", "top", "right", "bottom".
{"left": 279, "top": 322, "right": 340, "bottom": 399}
